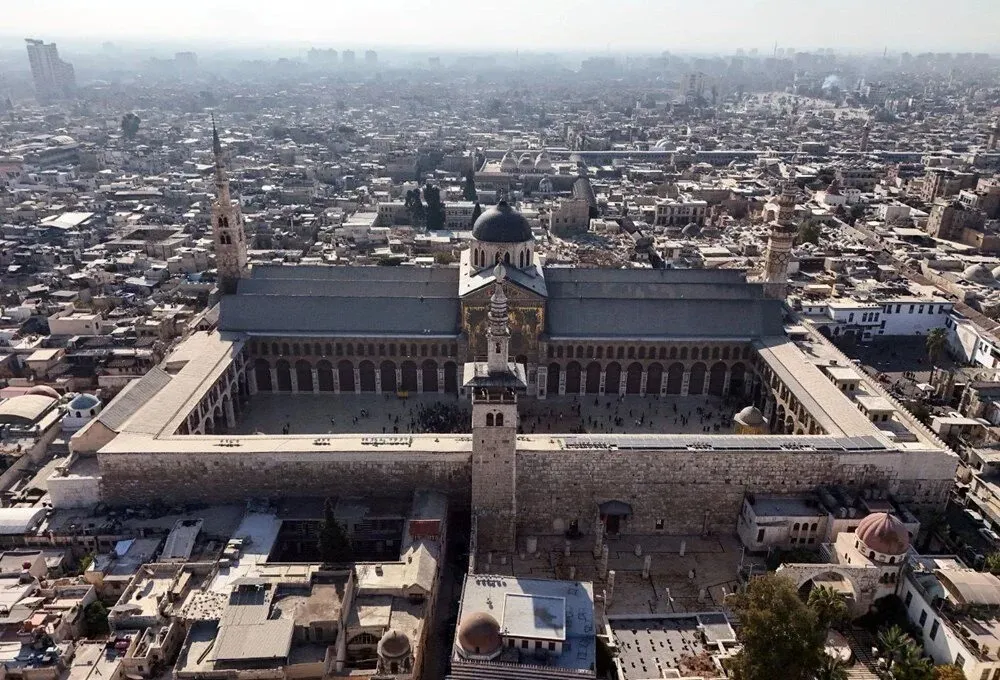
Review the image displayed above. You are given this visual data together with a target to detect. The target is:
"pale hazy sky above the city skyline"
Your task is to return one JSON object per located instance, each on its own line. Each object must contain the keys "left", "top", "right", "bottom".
{"left": 7, "top": 0, "right": 1000, "bottom": 52}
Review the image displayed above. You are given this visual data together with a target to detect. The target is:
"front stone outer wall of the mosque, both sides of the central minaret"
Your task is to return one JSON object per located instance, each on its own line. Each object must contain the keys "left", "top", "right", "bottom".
{"left": 98, "top": 451, "right": 957, "bottom": 536}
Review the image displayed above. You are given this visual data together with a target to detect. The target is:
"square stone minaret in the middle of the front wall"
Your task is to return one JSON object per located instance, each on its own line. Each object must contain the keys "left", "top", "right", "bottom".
{"left": 467, "top": 264, "right": 524, "bottom": 553}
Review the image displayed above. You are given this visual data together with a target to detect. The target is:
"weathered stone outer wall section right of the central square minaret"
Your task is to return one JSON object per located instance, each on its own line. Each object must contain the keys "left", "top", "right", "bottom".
{"left": 517, "top": 451, "right": 957, "bottom": 536}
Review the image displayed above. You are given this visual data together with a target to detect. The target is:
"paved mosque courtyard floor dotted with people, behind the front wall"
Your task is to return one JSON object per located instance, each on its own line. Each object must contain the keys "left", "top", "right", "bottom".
{"left": 230, "top": 392, "right": 746, "bottom": 434}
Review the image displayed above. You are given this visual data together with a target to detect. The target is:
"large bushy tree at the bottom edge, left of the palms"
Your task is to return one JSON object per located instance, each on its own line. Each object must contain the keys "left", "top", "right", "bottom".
{"left": 732, "top": 574, "right": 826, "bottom": 680}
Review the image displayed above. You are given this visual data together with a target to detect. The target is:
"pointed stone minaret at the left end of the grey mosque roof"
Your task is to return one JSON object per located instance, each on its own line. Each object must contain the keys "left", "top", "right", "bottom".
{"left": 212, "top": 116, "right": 247, "bottom": 295}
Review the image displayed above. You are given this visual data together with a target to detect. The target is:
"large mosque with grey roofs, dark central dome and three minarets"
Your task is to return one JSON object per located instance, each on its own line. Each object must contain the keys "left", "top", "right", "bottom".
{"left": 72, "top": 127, "right": 957, "bottom": 551}
